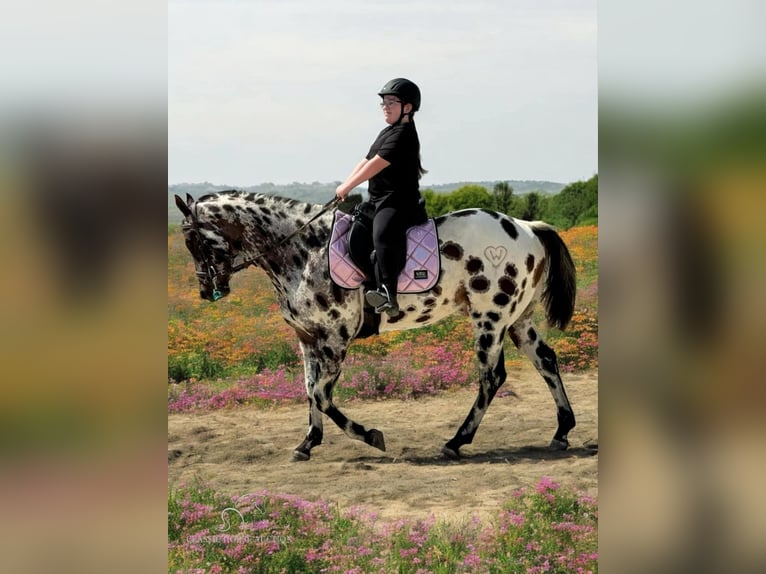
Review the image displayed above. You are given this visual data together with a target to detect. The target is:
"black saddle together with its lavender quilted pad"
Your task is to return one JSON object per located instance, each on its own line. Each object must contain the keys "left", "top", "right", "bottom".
{"left": 328, "top": 203, "right": 441, "bottom": 293}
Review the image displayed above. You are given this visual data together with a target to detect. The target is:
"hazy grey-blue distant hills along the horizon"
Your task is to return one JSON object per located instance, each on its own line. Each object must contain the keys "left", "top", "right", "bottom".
{"left": 168, "top": 180, "right": 567, "bottom": 223}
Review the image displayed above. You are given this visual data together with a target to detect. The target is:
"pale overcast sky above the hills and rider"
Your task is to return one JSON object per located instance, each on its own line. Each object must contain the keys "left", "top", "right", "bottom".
{"left": 168, "top": 0, "right": 598, "bottom": 186}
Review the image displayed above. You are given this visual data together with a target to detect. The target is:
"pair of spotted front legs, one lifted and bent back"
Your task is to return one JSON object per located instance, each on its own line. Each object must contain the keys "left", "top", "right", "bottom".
{"left": 293, "top": 345, "right": 386, "bottom": 461}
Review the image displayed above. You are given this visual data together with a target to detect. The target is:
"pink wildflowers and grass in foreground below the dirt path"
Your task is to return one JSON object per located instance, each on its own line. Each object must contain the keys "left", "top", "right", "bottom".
{"left": 168, "top": 477, "right": 598, "bottom": 574}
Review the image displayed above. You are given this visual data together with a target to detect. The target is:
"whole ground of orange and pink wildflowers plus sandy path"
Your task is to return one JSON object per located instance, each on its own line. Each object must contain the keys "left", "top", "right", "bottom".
{"left": 167, "top": 226, "right": 598, "bottom": 574}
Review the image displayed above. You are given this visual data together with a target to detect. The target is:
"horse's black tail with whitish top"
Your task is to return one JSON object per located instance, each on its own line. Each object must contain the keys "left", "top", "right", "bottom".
{"left": 531, "top": 225, "right": 577, "bottom": 331}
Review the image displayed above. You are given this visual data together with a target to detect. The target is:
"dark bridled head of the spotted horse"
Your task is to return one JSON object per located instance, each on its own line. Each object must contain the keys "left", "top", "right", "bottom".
{"left": 175, "top": 194, "right": 235, "bottom": 301}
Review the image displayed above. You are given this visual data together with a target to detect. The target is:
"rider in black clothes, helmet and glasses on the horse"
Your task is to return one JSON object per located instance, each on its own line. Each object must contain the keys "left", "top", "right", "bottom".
{"left": 335, "top": 78, "right": 427, "bottom": 316}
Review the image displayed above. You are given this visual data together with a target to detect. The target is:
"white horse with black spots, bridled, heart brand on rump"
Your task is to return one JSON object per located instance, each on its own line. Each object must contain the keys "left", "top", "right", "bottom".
{"left": 175, "top": 190, "right": 575, "bottom": 461}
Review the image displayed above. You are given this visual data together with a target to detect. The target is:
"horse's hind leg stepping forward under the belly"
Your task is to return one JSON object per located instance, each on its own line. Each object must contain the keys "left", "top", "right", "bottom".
{"left": 442, "top": 317, "right": 506, "bottom": 459}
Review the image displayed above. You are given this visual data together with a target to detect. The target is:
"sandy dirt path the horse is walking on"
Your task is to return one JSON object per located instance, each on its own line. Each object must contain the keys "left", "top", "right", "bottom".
{"left": 168, "top": 367, "right": 598, "bottom": 519}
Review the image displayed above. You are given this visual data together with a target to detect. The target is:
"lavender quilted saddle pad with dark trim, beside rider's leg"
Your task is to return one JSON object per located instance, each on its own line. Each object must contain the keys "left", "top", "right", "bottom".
{"left": 328, "top": 211, "right": 440, "bottom": 293}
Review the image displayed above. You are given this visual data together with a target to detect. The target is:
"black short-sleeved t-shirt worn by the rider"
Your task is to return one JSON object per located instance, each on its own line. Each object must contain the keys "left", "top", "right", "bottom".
{"left": 367, "top": 122, "right": 420, "bottom": 206}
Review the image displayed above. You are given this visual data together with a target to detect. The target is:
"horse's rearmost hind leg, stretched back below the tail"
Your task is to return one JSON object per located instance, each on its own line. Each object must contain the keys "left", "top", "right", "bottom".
{"left": 508, "top": 314, "right": 575, "bottom": 450}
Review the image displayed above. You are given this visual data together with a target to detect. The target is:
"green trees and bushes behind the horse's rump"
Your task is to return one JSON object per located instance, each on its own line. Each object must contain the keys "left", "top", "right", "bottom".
{"left": 422, "top": 174, "right": 598, "bottom": 229}
